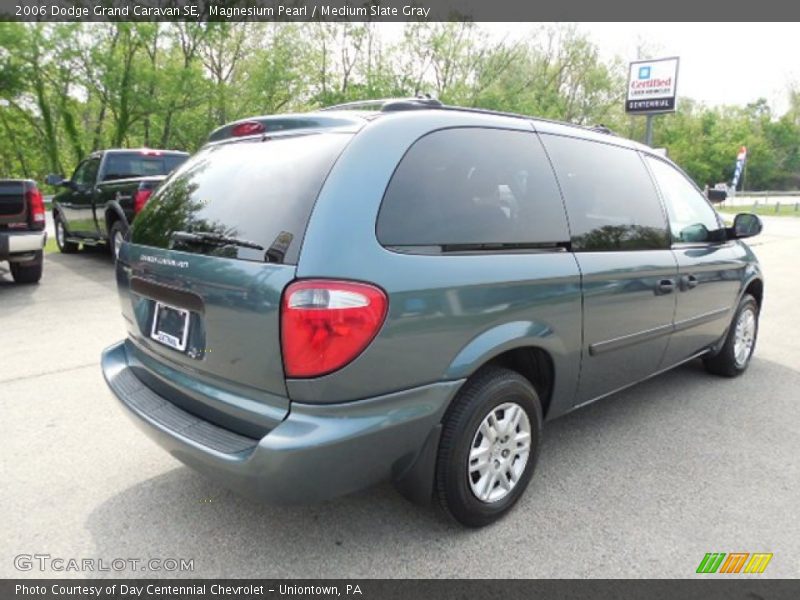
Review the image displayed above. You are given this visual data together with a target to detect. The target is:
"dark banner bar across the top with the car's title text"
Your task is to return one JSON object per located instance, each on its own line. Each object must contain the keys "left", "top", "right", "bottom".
{"left": 0, "top": 0, "right": 800, "bottom": 21}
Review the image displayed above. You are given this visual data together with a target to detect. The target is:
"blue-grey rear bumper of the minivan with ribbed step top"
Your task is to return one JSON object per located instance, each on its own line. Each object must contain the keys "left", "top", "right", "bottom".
{"left": 101, "top": 342, "right": 462, "bottom": 504}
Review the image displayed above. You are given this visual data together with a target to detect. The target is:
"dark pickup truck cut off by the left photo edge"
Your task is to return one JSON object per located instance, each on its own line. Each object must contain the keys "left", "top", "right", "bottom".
{"left": 0, "top": 179, "right": 47, "bottom": 283}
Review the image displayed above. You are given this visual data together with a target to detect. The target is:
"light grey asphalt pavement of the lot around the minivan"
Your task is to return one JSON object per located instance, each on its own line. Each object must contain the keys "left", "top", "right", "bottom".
{"left": 0, "top": 218, "right": 800, "bottom": 578}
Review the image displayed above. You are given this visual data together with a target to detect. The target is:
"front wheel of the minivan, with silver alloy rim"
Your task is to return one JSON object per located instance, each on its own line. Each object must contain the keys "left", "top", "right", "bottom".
{"left": 703, "top": 294, "right": 758, "bottom": 377}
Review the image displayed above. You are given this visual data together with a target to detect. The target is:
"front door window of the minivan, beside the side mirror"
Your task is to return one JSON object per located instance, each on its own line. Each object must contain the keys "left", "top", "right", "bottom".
{"left": 646, "top": 156, "right": 719, "bottom": 243}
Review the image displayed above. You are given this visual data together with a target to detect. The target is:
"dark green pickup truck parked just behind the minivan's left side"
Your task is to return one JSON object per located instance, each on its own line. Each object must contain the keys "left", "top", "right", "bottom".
{"left": 46, "top": 148, "right": 189, "bottom": 260}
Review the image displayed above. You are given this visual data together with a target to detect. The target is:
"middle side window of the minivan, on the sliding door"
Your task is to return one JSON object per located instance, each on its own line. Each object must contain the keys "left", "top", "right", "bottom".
{"left": 542, "top": 135, "right": 668, "bottom": 252}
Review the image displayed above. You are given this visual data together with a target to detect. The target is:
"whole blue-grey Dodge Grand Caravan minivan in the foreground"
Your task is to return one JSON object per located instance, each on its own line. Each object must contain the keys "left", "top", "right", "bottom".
{"left": 102, "top": 98, "right": 763, "bottom": 526}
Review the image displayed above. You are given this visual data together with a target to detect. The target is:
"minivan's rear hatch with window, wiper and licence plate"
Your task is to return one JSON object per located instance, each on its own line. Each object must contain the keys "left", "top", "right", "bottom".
{"left": 117, "top": 132, "right": 352, "bottom": 434}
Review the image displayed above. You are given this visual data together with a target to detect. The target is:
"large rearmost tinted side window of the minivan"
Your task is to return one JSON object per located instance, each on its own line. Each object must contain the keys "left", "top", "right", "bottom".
{"left": 377, "top": 128, "right": 569, "bottom": 250}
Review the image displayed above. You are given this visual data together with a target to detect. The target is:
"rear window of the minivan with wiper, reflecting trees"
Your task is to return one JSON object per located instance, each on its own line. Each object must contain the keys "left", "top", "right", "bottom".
{"left": 131, "top": 133, "right": 352, "bottom": 264}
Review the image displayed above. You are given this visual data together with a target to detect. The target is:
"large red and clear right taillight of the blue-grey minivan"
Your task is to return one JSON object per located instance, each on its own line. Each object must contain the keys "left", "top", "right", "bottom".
{"left": 281, "top": 279, "right": 388, "bottom": 377}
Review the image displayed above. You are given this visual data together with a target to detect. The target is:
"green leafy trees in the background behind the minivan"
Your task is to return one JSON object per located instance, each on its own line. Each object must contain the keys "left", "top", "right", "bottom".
{"left": 0, "top": 22, "right": 800, "bottom": 189}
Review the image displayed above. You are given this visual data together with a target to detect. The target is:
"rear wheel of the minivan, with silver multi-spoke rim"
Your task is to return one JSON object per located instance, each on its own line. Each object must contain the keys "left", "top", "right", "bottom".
{"left": 436, "top": 367, "right": 542, "bottom": 527}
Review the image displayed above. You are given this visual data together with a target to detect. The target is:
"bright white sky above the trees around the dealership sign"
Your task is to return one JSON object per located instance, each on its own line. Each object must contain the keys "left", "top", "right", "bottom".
{"left": 483, "top": 22, "right": 800, "bottom": 114}
